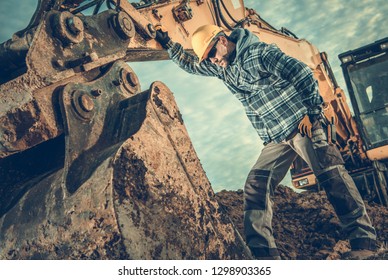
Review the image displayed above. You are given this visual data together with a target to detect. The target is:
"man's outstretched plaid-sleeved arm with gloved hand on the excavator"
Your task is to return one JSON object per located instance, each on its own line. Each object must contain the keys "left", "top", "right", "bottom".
{"left": 155, "top": 30, "right": 222, "bottom": 77}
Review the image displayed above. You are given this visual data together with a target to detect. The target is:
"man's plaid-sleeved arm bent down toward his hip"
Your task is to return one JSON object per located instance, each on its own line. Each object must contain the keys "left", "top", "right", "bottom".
{"left": 250, "top": 43, "right": 323, "bottom": 116}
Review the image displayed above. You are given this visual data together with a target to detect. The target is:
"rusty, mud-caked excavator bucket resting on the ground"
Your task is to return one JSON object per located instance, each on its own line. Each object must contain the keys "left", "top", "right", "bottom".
{"left": 0, "top": 61, "right": 251, "bottom": 259}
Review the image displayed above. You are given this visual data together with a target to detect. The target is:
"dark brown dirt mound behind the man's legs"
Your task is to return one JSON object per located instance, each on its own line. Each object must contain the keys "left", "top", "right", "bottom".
{"left": 217, "top": 185, "right": 388, "bottom": 260}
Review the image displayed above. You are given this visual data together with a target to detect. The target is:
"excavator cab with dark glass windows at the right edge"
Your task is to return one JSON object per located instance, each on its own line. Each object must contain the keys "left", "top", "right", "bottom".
{"left": 339, "top": 38, "right": 388, "bottom": 151}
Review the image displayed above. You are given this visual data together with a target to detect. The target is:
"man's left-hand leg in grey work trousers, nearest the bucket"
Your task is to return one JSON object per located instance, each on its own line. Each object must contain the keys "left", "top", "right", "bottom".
{"left": 244, "top": 143, "right": 296, "bottom": 259}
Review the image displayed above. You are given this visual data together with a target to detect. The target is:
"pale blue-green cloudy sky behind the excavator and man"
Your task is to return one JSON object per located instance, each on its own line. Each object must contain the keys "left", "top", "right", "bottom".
{"left": 0, "top": 0, "right": 388, "bottom": 191}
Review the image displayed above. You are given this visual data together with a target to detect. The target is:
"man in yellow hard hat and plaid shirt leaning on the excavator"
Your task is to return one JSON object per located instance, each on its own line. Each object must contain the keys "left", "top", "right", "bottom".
{"left": 156, "top": 25, "right": 376, "bottom": 259}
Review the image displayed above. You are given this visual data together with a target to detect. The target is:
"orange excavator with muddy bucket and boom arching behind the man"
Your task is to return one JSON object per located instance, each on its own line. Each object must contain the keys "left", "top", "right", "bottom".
{"left": 0, "top": 0, "right": 387, "bottom": 259}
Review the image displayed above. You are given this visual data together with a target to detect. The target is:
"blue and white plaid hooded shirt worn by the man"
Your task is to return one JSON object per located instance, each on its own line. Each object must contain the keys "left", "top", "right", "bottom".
{"left": 168, "top": 29, "right": 323, "bottom": 144}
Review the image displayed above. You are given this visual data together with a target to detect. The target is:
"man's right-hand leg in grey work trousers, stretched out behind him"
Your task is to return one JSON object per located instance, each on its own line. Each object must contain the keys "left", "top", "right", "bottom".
{"left": 289, "top": 119, "right": 376, "bottom": 250}
